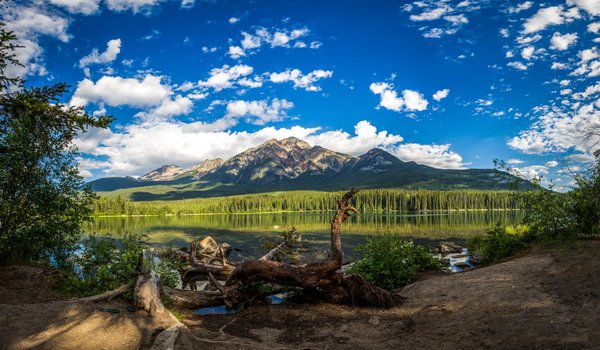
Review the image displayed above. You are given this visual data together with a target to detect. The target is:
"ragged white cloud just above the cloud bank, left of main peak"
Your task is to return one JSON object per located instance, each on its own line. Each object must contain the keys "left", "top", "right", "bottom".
{"left": 225, "top": 98, "right": 294, "bottom": 125}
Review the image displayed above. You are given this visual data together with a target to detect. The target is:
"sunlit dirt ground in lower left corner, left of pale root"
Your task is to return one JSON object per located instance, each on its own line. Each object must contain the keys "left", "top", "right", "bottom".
{"left": 0, "top": 266, "right": 155, "bottom": 350}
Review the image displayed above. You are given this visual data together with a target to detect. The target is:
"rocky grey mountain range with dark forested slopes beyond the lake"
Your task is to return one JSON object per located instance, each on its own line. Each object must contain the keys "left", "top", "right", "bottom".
{"left": 88, "top": 137, "right": 515, "bottom": 200}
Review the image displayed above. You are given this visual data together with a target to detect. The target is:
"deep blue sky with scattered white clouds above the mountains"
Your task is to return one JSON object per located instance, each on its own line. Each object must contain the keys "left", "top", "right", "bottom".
{"left": 1, "top": 0, "right": 600, "bottom": 184}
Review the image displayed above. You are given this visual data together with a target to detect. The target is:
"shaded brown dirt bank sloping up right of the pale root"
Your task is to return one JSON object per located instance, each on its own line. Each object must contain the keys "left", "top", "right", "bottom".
{"left": 178, "top": 242, "right": 600, "bottom": 349}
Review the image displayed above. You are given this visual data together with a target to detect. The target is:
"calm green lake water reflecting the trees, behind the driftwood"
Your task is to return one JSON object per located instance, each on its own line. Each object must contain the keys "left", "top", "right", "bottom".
{"left": 85, "top": 211, "right": 524, "bottom": 259}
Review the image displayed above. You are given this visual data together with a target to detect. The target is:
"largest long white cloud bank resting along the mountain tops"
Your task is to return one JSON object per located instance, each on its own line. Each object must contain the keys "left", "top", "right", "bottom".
{"left": 76, "top": 117, "right": 465, "bottom": 176}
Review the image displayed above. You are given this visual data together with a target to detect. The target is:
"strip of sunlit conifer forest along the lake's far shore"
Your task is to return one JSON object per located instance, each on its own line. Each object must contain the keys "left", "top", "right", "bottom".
{"left": 93, "top": 189, "right": 525, "bottom": 216}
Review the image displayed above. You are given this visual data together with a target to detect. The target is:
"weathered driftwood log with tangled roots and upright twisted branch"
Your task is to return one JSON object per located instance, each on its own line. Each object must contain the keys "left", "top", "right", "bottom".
{"left": 155, "top": 189, "right": 402, "bottom": 308}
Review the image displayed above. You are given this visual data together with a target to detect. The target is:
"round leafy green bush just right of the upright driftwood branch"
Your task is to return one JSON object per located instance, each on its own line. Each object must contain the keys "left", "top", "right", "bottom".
{"left": 349, "top": 235, "right": 446, "bottom": 290}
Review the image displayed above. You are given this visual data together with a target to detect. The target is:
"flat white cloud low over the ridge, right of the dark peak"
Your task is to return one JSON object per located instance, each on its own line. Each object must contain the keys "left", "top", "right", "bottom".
{"left": 390, "top": 143, "right": 466, "bottom": 169}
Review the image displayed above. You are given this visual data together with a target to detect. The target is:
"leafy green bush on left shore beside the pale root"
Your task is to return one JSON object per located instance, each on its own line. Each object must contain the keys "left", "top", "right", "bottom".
{"left": 59, "top": 233, "right": 146, "bottom": 296}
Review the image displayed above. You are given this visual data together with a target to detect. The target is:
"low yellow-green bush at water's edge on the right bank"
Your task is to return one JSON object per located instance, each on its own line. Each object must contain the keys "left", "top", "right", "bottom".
{"left": 467, "top": 225, "right": 530, "bottom": 264}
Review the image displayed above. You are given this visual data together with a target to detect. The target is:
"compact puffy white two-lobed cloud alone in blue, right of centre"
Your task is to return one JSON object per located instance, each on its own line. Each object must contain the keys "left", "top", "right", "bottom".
{"left": 369, "top": 82, "right": 429, "bottom": 112}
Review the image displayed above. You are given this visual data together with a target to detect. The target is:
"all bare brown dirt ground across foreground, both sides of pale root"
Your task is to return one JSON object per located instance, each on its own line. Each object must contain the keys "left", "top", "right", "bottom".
{"left": 0, "top": 241, "right": 600, "bottom": 349}
